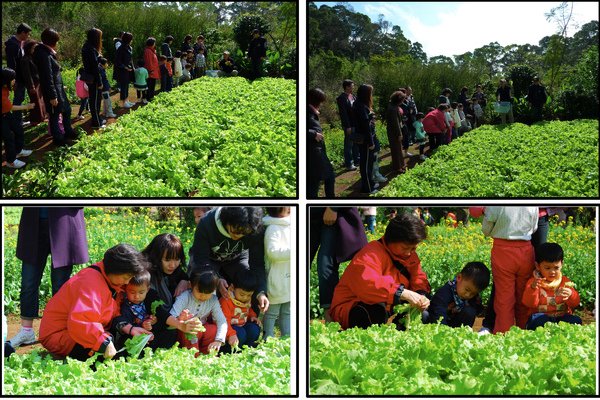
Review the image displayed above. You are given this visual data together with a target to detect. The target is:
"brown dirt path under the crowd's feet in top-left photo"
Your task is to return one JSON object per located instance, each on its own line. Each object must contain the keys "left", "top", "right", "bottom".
{"left": 2, "top": 88, "right": 152, "bottom": 175}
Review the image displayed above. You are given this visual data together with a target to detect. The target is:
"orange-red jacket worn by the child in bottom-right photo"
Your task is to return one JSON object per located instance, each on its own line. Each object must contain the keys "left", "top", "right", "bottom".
{"left": 523, "top": 275, "right": 579, "bottom": 317}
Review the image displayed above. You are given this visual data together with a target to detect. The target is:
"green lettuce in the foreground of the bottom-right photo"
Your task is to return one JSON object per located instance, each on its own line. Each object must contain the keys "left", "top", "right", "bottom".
{"left": 309, "top": 321, "right": 597, "bottom": 396}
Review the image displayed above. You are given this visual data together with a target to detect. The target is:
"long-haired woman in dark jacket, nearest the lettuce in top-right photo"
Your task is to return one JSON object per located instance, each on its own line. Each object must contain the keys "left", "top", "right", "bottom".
{"left": 352, "top": 84, "right": 377, "bottom": 194}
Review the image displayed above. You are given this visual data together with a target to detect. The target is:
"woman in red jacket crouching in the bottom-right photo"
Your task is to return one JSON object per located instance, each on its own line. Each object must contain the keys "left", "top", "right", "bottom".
{"left": 329, "top": 213, "right": 431, "bottom": 329}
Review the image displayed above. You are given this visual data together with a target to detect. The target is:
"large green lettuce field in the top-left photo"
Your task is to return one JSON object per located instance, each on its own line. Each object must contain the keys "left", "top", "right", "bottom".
{"left": 4, "top": 77, "right": 297, "bottom": 198}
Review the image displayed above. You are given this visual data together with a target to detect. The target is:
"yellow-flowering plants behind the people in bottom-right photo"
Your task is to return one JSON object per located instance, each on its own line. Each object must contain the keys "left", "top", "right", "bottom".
{"left": 310, "top": 221, "right": 596, "bottom": 318}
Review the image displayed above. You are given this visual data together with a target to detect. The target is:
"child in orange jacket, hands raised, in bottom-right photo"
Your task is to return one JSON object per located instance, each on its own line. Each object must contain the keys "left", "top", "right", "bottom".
{"left": 523, "top": 243, "right": 581, "bottom": 330}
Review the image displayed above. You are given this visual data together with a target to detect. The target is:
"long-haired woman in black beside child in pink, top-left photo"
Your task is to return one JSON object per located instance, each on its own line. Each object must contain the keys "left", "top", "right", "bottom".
{"left": 81, "top": 28, "right": 104, "bottom": 128}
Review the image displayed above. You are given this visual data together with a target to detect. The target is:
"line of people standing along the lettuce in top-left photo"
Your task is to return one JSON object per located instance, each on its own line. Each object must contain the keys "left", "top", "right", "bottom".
{"left": 2, "top": 23, "right": 267, "bottom": 168}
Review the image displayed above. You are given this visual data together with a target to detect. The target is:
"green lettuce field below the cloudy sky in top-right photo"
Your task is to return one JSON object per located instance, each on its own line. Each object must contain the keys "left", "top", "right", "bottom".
{"left": 377, "top": 120, "right": 598, "bottom": 198}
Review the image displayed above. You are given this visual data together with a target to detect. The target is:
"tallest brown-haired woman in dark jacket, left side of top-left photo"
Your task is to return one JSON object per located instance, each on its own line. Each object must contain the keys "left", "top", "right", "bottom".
{"left": 33, "top": 28, "right": 76, "bottom": 146}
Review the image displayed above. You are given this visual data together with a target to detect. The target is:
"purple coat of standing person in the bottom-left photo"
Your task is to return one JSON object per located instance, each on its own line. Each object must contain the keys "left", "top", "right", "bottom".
{"left": 17, "top": 207, "right": 89, "bottom": 268}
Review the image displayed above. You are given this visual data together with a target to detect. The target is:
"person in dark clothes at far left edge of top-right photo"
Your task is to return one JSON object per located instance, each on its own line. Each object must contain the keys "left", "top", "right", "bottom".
{"left": 308, "top": 89, "right": 335, "bottom": 199}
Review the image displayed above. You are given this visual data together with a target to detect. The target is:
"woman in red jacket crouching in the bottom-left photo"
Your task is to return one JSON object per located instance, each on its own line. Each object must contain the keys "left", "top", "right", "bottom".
{"left": 40, "top": 244, "right": 150, "bottom": 361}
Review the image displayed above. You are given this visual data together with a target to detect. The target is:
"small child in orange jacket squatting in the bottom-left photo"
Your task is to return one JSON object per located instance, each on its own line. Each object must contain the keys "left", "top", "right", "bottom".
{"left": 219, "top": 265, "right": 260, "bottom": 353}
